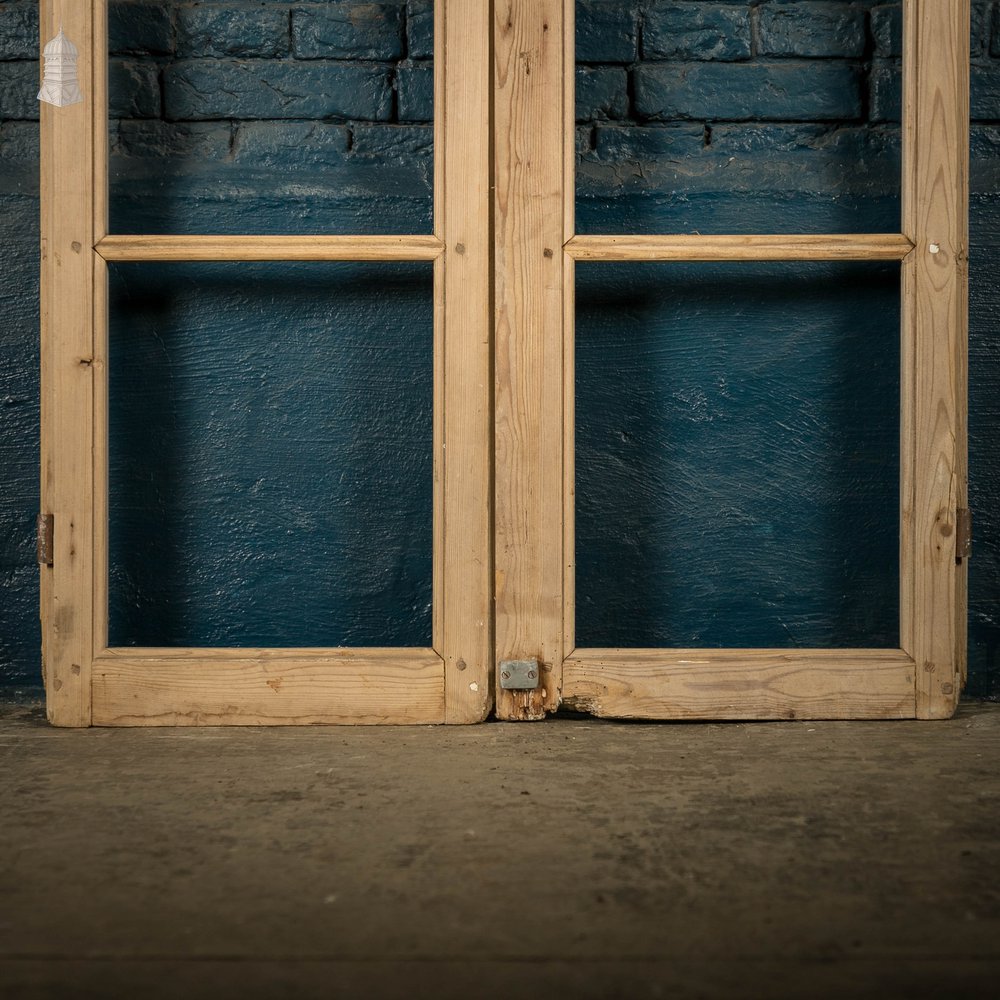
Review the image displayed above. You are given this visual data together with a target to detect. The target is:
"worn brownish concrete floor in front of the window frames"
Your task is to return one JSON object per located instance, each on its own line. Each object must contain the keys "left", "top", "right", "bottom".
{"left": 0, "top": 705, "right": 1000, "bottom": 1000}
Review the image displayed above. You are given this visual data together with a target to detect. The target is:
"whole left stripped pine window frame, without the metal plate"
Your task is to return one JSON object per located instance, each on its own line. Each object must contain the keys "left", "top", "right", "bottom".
{"left": 43, "top": 0, "right": 472, "bottom": 725}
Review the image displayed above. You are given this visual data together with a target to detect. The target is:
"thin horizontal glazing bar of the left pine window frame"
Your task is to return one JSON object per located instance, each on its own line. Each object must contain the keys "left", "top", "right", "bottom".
{"left": 96, "top": 236, "right": 444, "bottom": 261}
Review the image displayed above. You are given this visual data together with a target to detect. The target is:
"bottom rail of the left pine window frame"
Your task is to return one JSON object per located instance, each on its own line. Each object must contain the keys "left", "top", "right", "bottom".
{"left": 93, "top": 649, "right": 444, "bottom": 726}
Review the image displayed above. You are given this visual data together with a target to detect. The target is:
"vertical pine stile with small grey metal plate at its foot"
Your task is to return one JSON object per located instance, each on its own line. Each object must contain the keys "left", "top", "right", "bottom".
{"left": 494, "top": 0, "right": 571, "bottom": 719}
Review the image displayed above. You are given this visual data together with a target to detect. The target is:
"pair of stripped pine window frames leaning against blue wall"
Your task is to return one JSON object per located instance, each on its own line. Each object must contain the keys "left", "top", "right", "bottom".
{"left": 41, "top": 0, "right": 969, "bottom": 726}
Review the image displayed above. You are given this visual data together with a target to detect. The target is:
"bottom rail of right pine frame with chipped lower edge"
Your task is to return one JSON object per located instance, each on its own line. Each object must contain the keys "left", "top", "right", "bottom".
{"left": 563, "top": 649, "right": 914, "bottom": 719}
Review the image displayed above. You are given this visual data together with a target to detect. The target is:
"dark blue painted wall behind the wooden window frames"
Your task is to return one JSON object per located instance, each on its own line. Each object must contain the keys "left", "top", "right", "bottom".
{"left": 0, "top": 0, "right": 1000, "bottom": 697}
